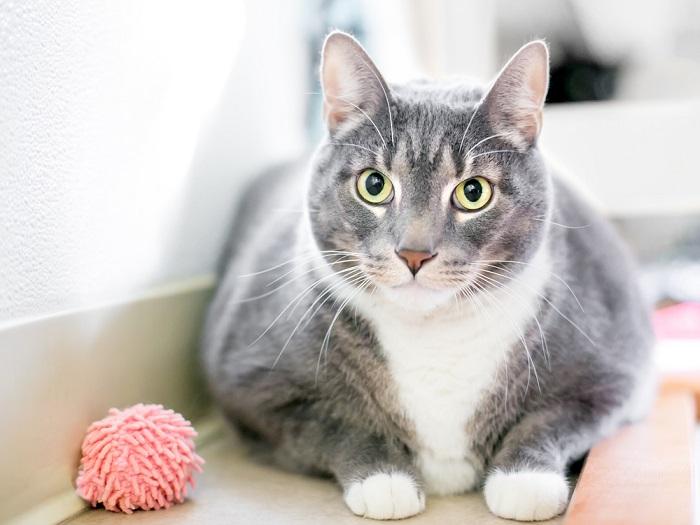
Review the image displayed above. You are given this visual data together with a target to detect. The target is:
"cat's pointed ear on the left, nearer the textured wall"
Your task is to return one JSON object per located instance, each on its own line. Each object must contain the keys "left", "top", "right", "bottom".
{"left": 321, "top": 31, "right": 389, "bottom": 132}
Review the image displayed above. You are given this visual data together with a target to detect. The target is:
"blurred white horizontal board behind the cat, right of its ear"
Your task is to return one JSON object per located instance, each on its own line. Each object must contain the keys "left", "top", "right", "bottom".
{"left": 541, "top": 99, "right": 700, "bottom": 217}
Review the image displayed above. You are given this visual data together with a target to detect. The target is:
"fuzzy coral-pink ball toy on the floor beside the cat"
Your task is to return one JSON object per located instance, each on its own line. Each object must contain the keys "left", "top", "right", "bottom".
{"left": 76, "top": 404, "right": 204, "bottom": 514}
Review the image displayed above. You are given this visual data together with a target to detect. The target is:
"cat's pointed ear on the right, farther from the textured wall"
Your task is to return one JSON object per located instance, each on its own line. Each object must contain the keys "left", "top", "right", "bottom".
{"left": 482, "top": 40, "right": 549, "bottom": 146}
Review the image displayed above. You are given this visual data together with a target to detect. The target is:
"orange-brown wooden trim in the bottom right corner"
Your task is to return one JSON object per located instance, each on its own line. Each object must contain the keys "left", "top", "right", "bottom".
{"left": 564, "top": 390, "right": 700, "bottom": 525}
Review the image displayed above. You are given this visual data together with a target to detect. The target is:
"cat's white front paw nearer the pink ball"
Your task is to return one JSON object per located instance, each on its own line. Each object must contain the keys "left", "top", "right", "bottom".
{"left": 344, "top": 472, "right": 425, "bottom": 520}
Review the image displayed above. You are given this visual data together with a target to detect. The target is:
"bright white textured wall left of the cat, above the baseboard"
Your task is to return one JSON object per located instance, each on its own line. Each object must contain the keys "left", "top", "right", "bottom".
{"left": 0, "top": 0, "right": 305, "bottom": 325}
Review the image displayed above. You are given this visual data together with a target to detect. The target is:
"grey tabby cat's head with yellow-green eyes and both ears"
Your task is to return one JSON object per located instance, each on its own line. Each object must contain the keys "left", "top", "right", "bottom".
{"left": 308, "top": 32, "right": 551, "bottom": 309}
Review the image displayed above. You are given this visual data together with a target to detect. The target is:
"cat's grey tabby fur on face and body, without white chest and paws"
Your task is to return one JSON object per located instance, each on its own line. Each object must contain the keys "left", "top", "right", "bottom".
{"left": 203, "top": 32, "right": 652, "bottom": 520}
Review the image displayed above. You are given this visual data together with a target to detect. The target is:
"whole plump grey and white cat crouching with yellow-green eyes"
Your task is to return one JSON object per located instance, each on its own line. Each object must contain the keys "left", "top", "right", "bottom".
{"left": 203, "top": 32, "right": 653, "bottom": 520}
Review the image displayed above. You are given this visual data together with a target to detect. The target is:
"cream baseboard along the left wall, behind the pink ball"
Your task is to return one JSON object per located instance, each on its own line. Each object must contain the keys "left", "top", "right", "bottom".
{"left": 0, "top": 276, "right": 214, "bottom": 524}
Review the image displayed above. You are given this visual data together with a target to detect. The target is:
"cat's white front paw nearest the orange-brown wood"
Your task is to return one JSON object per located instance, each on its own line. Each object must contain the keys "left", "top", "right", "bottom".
{"left": 484, "top": 470, "right": 569, "bottom": 521}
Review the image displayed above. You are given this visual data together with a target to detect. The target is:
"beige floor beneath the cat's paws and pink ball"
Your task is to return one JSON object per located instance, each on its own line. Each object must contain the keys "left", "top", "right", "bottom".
{"left": 64, "top": 426, "right": 561, "bottom": 525}
